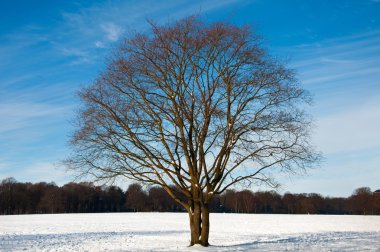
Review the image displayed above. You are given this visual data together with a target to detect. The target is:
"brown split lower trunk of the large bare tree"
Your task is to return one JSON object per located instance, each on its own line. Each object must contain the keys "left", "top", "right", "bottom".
{"left": 189, "top": 203, "right": 210, "bottom": 247}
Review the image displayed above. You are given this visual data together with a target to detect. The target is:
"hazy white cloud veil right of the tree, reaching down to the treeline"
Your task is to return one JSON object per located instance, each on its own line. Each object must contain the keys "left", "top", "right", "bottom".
{"left": 276, "top": 30, "right": 380, "bottom": 196}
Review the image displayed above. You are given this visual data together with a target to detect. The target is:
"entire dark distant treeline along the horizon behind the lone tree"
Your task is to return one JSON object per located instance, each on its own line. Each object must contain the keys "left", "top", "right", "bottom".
{"left": 0, "top": 178, "right": 380, "bottom": 215}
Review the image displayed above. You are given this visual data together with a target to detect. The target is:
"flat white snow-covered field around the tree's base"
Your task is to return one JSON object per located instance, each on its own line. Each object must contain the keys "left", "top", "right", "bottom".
{"left": 0, "top": 213, "right": 380, "bottom": 251}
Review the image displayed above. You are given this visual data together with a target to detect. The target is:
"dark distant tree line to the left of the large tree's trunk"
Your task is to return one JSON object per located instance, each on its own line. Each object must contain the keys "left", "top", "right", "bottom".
{"left": 0, "top": 178, "right": 184, "bottom": 214}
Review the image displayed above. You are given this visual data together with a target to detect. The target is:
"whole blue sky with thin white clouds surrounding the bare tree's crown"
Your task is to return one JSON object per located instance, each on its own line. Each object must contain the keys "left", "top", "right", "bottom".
{"left": 0, "top": 0, "right": 380, "bottom": 196}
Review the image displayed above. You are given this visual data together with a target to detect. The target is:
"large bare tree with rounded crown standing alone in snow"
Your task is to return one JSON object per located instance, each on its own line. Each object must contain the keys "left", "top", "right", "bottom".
{"left": 67, "top": 17, "right": 318, "bottom": 246}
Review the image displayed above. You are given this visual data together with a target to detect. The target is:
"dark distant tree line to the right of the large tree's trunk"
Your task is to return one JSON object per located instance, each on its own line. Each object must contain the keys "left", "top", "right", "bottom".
{"left": 219, "top": 187, "right": 380, "bottom": 215}
